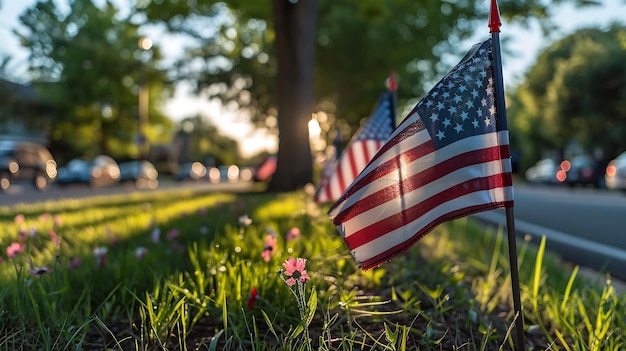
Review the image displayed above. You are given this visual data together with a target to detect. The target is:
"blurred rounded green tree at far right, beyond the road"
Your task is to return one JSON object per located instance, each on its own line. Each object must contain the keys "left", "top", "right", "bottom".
{"left": 510, "top": 25, "right": 626, "bottom": 167}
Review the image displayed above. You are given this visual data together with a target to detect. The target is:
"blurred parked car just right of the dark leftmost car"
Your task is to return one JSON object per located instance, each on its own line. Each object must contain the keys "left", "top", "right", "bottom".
{"left": 57, "top": 155, "right": 120, "bottom": 188}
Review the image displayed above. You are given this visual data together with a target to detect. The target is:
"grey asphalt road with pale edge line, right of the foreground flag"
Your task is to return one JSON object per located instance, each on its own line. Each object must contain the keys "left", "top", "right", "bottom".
{"left": 473, "top": 185, "right": 626, "bottom": 280}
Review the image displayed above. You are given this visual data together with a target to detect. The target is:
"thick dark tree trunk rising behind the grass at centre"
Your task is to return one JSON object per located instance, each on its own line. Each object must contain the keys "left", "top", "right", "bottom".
{"left": 268, "top": 0, "right": 317, "bottom": 191}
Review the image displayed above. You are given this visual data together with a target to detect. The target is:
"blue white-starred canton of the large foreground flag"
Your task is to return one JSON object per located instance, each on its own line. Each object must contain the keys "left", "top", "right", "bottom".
{"left": 417, "top": 40, "right": 499, "bottom": 149}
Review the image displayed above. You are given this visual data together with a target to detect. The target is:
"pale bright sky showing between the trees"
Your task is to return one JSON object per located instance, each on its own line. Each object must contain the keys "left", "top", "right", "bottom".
{"left": 0, "top": 0, "right": 626, "bottom": 155}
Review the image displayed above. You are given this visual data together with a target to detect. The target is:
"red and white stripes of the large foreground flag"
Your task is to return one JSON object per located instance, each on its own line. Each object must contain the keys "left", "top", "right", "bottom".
{"left": 329, "top": 110, "right": 513, "bottom": 269}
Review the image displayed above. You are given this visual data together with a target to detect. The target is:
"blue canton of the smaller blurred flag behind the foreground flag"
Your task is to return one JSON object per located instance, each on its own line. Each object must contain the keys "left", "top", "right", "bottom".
{"left": 356, "top": 93, "right": 396, "bottom": 141}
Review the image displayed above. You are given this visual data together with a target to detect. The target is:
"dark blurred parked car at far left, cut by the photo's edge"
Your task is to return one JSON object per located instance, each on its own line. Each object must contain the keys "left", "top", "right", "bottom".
{"left": 0, "top": 140, "right": 57, "bottom": 192}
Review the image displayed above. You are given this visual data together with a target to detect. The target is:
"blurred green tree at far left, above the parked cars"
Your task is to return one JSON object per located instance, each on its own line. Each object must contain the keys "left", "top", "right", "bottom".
{"left": 16, "top": 0, "right": 172, "bottom": 158}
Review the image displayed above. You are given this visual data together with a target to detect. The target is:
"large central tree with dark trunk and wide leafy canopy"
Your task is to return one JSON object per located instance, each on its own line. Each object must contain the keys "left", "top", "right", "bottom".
{"left": 138, "top": 0, "right": 597, "bottom": 190}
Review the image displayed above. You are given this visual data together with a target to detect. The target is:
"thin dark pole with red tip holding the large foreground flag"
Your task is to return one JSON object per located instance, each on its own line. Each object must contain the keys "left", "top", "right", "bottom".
{"left": 489, "top": 0, "right": 526, "bottom": 350}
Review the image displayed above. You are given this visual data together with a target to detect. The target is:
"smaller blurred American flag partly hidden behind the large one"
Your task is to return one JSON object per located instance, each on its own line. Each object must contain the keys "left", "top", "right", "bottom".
{"left": 314, "top": 92, "right": 396, "bottom": 203}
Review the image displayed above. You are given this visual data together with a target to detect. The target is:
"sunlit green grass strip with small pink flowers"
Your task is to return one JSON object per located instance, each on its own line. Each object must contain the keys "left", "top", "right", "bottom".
{"left": 0, "top": 191, "right": 626, "bottom": 350}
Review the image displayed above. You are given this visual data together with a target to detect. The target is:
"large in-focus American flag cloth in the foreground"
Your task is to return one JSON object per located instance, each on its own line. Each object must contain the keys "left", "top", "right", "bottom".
{"left": 329, "top": 40, "right": 513, "bottom": 270}
